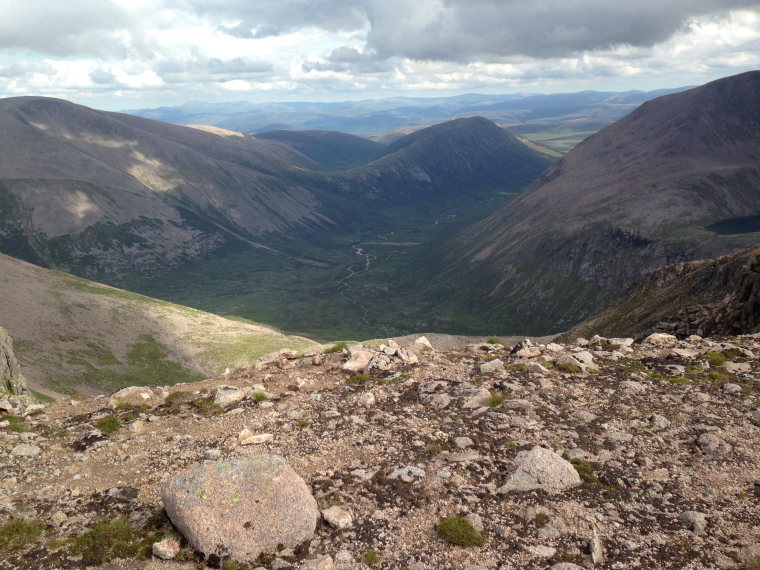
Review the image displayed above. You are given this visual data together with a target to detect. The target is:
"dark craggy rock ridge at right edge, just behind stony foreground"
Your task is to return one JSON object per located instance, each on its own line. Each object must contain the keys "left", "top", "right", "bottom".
{"left": 564, "top": 246, "right": 760, "bottom": 338}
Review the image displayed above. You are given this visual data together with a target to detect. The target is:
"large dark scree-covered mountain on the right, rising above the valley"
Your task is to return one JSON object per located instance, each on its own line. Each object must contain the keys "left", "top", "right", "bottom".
{"left": 442, "top": 72, "right": 760, "bottom": 334}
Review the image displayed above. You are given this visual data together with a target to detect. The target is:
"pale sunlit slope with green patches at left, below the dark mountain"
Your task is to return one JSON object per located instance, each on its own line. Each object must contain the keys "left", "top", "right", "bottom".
{"left": 0, "top": 254, "right": 316, "bottom": 394}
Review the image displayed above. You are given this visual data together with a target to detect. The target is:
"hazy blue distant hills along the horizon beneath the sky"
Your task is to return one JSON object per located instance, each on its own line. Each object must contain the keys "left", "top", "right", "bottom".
{"left": 125, "top": 88, "right": 686, "bottom": 150}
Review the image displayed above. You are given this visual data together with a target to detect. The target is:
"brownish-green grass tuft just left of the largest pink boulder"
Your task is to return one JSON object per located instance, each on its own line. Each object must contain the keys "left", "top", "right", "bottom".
{"left": 69, "top": 519, "right": 161, "bottom": 566}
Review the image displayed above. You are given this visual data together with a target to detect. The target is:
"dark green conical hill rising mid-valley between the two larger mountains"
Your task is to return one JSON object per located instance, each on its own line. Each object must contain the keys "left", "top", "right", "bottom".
{"left": 338, "top": 117, "right": 556, "bottom": 202}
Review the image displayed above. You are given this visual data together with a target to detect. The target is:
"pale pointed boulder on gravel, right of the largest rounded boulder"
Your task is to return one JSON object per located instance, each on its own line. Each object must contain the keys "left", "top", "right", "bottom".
{"left": 498, "top": 447, "right": 581, "bottom": 493}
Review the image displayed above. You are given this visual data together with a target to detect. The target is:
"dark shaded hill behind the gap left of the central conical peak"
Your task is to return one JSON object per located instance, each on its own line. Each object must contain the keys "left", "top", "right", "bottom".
{"left": 256, "top": 130, "right": 385, "bottom": 170}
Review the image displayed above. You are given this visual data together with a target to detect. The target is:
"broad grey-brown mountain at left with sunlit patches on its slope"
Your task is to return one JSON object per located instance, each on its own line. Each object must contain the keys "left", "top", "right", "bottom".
{"left": 0, "top": 97, "right": 329, "bottom": 274}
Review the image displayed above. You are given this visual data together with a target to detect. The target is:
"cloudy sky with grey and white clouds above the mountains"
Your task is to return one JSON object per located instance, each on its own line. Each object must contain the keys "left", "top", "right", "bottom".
{"left": 0, "top": 0, "right": 760, "bottom": 110}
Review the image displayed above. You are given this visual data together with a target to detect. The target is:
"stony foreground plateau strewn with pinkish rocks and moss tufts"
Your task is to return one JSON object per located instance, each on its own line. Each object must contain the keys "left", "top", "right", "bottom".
{"left": 0, "top": 335, "right": 760, "bottom": 570}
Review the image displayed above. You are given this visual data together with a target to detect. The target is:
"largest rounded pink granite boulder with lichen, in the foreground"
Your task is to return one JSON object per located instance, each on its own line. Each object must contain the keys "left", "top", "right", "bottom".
{"left": 161, "top": 455, "right": 320, "bottom": 562}
